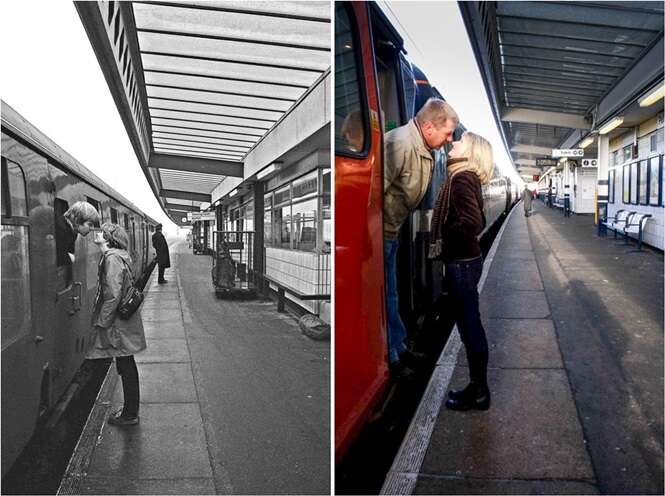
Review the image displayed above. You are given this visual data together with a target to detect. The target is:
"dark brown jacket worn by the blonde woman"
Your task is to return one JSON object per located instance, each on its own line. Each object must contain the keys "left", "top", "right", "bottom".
{"left": 441, "top": 171, "right": 485, "bottom": 263}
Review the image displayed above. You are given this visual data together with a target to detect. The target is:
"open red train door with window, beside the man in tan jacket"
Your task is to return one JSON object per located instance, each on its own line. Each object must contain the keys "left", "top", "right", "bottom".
{"left": 335, "top": 2, "right": 388, "bottom": 457}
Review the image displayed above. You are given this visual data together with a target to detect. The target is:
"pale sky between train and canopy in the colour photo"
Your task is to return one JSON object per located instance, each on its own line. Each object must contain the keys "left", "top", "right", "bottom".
{"left": 379, "top": 1, "right": 521, "bottom": 182}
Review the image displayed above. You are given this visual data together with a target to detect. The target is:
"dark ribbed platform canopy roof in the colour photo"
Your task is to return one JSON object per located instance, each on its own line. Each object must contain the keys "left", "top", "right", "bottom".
{"left": 459, "top": 1, "right": 663, "bottom": 180}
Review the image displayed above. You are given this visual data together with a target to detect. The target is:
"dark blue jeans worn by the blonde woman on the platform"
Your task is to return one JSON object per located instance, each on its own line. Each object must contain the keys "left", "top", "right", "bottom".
{"left": 446, "top": 257, "right": 488, "bottom": 386}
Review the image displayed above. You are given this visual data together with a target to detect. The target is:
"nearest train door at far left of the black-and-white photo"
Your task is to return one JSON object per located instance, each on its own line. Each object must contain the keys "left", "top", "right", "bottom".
{"left": 1, "top": 157, "right": 39, "bottom": 476}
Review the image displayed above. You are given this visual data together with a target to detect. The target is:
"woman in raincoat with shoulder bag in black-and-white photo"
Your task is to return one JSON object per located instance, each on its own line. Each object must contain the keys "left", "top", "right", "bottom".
{"left": 87, "top": 223, "right": 146, "bottom": 425}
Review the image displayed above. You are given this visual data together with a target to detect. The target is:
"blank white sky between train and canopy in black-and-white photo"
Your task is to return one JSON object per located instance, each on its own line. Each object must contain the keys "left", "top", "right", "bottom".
{"left": 0, "top": 1, "right": 177, "bottom": 233}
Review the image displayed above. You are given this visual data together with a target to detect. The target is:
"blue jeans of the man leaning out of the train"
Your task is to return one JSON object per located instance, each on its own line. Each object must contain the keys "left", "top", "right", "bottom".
{"left": 383, "top": 239, "right": 406, "bottom": 363}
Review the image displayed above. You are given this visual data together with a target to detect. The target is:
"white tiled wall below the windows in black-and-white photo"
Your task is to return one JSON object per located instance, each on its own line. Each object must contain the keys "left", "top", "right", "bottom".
{"left": 265, "top": 247, "right": 330, "bottom": 322}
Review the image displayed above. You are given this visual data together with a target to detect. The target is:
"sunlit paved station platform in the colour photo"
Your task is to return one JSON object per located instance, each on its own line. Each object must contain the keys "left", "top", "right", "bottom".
{"left": 382, "top": 202, "right": 664, "bottom": 494}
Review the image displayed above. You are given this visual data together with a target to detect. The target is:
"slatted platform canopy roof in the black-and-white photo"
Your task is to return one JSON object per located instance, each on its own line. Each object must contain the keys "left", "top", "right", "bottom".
{"left": 76, "top": 1, "right": 330, "bottom": 224}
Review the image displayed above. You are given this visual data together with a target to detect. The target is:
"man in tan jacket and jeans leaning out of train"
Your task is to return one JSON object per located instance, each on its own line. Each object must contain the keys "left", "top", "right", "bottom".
{"left": 383, "top": 98, "right": 459, "bottom": 378}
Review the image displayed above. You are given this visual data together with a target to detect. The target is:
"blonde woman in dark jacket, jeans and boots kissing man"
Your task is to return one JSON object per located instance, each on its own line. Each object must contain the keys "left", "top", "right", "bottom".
{"left": 429, "top": 132, "right": 494, "bottom": 410}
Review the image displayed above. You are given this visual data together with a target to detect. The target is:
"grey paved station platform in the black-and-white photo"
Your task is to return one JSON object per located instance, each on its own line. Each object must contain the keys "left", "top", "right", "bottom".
{"left": 58, "top": 243, "right": 330, "bottom": 494}
